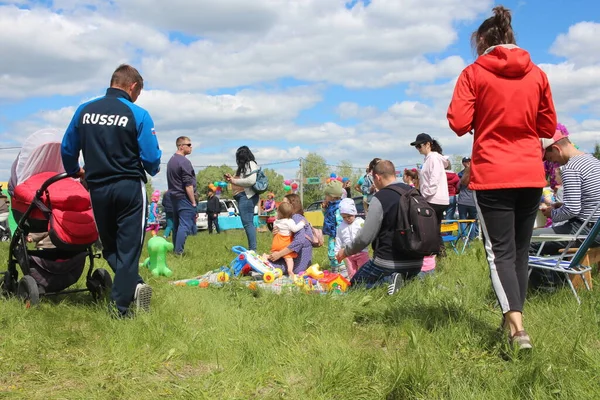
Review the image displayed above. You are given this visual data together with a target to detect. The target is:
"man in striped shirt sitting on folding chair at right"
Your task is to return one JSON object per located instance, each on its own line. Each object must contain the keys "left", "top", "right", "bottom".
{"left": 532, "top": 131, "right": 600, "bottom": 254}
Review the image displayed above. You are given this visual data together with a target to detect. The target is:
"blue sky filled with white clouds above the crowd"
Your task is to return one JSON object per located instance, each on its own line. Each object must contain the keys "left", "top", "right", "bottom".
{"left": 0, "top": 0, "right": 600, "bottom": 187}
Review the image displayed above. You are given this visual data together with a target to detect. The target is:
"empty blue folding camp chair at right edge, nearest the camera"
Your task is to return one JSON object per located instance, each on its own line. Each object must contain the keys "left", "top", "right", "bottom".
{"left": 529, "top": 204, "right": 600, "bottom": 304}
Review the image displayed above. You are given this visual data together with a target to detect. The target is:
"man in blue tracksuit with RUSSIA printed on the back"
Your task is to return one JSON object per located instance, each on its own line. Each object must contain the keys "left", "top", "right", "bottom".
{"left": 61, "top": 64, "right": 162, "bottom": 316}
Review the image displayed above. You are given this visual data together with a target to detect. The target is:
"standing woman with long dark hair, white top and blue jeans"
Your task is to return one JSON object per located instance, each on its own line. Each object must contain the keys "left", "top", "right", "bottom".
{"left": 225, "top": 146, "right": 259, "bottom": 250}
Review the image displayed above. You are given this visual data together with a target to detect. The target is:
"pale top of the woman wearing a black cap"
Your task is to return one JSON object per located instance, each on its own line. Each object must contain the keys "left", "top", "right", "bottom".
{"left": 419, "top": 151, "right": 450, "bottom": 205}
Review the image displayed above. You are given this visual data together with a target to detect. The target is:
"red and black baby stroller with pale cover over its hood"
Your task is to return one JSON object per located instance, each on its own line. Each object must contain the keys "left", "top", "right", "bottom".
{"left": 0, "top": 129, "right": 112, "bottom": 307}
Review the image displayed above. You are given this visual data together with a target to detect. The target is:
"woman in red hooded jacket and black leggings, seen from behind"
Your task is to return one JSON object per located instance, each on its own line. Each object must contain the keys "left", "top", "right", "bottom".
{"left": 448, "top": 6, "right": 556, "bottom": 349}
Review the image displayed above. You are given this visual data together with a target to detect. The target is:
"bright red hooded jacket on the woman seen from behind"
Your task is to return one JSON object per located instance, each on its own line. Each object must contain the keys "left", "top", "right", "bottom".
{"left": 448, "top": 45, "right": 556, "bottom": 190}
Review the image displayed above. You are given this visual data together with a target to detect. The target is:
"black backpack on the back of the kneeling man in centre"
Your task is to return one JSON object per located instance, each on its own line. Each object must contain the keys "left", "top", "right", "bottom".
{"left": 385, "top": 184, "right": 442, "bottom": 257}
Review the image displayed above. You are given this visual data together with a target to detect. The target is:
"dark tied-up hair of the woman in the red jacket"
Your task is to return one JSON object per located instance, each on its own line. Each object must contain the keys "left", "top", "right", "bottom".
{"left": 471, "top": 6, "right": 517, "bottom": 55}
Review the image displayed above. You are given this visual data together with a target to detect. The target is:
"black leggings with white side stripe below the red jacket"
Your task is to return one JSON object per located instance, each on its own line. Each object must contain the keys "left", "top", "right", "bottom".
{"left": 474, "top": 188, "right": 542, "bottom": 314}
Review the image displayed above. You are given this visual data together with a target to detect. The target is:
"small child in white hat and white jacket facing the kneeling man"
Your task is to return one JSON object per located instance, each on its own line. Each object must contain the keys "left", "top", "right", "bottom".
{"left": 335, "top": 198, "right": 369, "bottom": 279}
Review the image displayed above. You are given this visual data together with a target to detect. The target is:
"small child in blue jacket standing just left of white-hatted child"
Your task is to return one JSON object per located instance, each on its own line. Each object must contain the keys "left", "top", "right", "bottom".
{"left": 322, "top": 180, "right": 344, "bottom": 272}
